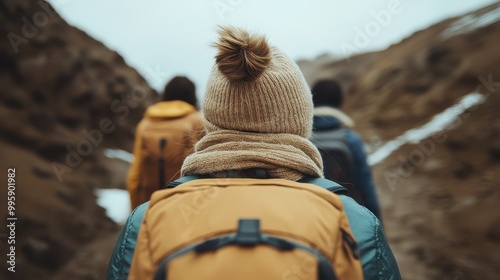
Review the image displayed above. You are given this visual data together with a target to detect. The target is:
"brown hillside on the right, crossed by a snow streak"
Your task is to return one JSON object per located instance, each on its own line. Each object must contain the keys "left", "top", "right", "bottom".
{"left": 300, "top": 3, "right": 500, "bottom": 279}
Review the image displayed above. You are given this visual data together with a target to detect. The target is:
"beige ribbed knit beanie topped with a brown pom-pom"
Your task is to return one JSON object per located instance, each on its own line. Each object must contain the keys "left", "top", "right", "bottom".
{"left": 202, "top": 27, "right": 313, "bottom": 138}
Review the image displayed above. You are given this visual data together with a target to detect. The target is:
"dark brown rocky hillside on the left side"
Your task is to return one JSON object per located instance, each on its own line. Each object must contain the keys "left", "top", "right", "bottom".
{"left": 0, "top": 0, "right": 157, "bottom": 279}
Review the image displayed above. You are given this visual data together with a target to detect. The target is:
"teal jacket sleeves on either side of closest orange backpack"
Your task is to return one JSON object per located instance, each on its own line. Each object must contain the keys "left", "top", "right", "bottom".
{"left": 106, "top": 178, "right": 401, "bottom": 280}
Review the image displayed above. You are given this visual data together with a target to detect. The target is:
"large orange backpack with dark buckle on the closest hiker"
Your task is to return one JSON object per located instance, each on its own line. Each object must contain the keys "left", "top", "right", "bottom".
{"left": 129, "top": 176, "right": 363, "bottom": 280}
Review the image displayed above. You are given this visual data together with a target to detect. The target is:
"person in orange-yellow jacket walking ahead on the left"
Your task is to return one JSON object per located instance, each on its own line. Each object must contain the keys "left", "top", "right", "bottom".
{"left": 127, "top": 76, "right": 204, "bottom": 209}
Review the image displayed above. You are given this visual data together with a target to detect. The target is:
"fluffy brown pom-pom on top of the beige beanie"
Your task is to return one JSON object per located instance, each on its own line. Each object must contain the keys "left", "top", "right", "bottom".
{"left": 214, "top": 27, "right": 271, "bottom": 81}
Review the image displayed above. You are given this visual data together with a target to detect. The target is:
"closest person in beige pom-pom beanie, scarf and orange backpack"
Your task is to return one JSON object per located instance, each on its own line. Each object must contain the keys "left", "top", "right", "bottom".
{"left": 107, "top": 27, "right": 401, "bottom": 279}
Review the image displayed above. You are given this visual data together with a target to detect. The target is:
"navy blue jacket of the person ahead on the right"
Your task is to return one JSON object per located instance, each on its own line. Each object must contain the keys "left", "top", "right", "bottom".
{"left": 313, "top": 116, "right": 382, "bottom": 220}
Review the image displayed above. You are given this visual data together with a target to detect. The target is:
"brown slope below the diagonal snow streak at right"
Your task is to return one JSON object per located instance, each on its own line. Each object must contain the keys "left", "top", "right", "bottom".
{"left": 374, "top": 88, "right": 500, "bottom": 280}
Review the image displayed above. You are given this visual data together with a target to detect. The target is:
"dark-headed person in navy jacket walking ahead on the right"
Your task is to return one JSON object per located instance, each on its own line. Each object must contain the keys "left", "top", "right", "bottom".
{"left": 311, "top": 80, "right": 382, "bottom": 220}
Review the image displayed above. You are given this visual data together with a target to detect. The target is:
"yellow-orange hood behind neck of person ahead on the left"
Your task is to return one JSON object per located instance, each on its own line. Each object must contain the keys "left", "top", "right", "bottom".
{"left": 144, "top": 100, "right": 196, "bottom": 119}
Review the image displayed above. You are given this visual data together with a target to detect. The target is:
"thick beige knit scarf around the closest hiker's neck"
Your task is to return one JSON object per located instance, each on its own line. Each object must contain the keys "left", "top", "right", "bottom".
{"left": 181, "top": 130, "right": 323, "bottom": 181}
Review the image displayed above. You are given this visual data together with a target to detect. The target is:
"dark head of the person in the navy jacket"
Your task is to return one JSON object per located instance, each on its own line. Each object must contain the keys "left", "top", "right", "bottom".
{"left": 311, "top": 80, "right": 344, "bottom": 108}
